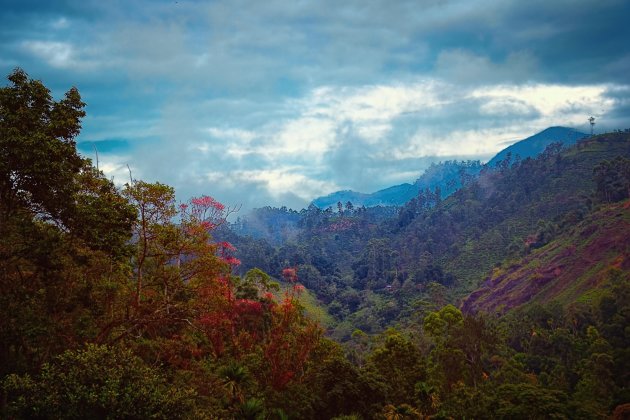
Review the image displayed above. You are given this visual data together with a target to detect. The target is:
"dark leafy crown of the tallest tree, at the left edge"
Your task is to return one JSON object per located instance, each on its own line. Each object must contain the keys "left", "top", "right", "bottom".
{"left": 0, "top": 69, "right": 85, "bottom": 223}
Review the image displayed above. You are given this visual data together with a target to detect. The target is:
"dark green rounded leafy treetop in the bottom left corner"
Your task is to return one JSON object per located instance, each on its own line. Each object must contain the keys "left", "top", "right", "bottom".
{"left": 3, "top": 345, "right": 195, "bottom": 419}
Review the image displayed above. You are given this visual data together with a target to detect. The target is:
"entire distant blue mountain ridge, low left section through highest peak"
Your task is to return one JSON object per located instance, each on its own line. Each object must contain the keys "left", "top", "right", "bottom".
{"left": 312, "top": 126, "right": 588, "bottom": 209}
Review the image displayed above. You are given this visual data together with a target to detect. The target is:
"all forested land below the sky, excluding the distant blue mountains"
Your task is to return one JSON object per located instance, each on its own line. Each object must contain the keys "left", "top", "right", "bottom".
{"left": 0, "top": 69, "right": 630, "bottom": 419}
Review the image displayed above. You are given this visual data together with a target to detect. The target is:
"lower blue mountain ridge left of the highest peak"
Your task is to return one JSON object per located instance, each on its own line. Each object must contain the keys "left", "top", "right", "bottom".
{"left": 312, "top": 160, "right": 482, "bottom": 209}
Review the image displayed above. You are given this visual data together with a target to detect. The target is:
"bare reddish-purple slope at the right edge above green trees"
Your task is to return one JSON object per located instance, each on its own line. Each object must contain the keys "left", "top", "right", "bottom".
{"left": 462, "top": 201, "right": 630, "bottom": 313}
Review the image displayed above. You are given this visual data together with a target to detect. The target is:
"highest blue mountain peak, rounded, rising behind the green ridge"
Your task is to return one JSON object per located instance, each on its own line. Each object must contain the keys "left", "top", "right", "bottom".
{"left": 487, "top": 127, "right": 588, "bottom": 168}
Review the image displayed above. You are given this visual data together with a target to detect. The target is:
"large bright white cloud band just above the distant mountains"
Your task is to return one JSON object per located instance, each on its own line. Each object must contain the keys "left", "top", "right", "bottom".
{"left": 146, "top": 78, "right": 624, "bottom": 203}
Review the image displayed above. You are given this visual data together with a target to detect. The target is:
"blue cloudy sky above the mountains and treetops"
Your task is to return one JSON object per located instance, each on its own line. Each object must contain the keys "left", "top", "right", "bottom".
{"left": 0, "top": 0, "right": 630, "bottom": 209}
